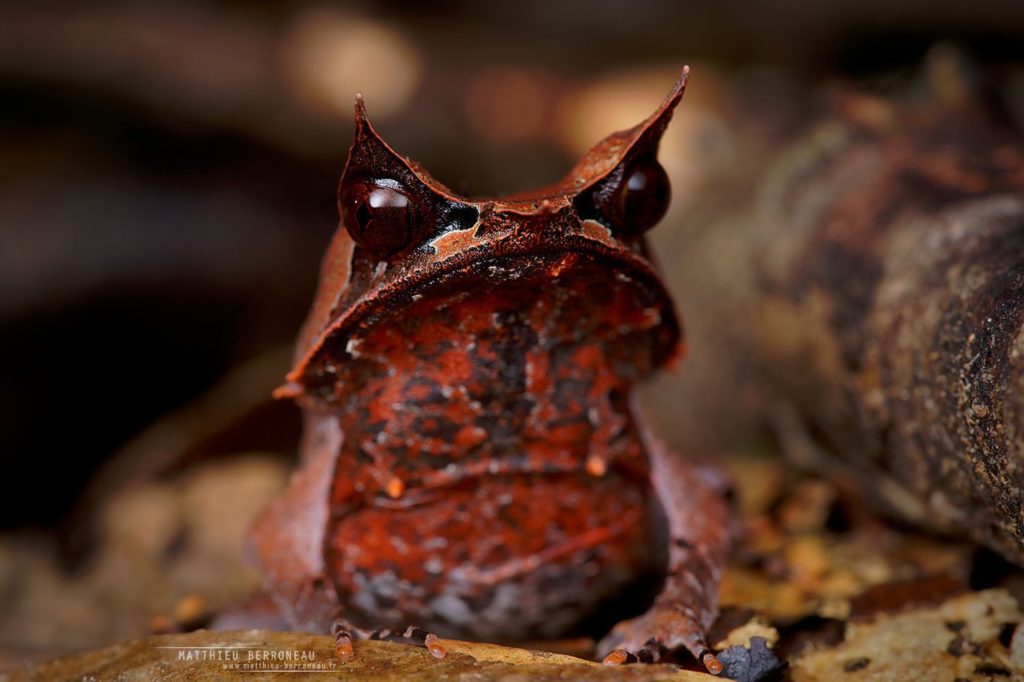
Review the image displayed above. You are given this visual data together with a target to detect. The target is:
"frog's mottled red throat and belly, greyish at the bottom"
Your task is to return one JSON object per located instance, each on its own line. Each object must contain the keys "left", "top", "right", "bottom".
{"left": 326, "top": 249, "right": 658, "bottom": 639}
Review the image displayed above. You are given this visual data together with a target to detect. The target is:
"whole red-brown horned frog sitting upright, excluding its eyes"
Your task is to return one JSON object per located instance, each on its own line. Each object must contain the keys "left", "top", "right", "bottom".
{"left": 246, "top": 73, "right": 727, "bottom": 670}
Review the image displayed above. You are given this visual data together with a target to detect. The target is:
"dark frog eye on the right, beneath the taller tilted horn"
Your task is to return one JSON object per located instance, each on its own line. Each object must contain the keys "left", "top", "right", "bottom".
{"left": 592, "top": 160, "right": 672, "bottom": 235}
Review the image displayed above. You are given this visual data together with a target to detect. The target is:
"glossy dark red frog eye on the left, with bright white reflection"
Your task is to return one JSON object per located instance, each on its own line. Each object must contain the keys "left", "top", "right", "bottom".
{"left": 340, "top": 181, "right": 426, "bottom": 258}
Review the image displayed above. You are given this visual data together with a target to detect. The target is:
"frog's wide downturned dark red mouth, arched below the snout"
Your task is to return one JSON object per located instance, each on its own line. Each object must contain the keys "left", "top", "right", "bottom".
{"left": 279, "top": 233, "right": 682, "bottom": 400}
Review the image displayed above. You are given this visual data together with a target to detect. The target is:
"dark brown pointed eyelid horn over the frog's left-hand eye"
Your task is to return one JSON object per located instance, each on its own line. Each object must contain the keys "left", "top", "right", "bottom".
{"left": 338, "top": 94, "right": 477, "bottom": 242}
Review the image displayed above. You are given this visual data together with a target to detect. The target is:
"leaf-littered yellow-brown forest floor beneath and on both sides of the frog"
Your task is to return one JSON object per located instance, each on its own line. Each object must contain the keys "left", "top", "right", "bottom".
{"left": 0, "top": 446, "right": 1024, "bottom": 682}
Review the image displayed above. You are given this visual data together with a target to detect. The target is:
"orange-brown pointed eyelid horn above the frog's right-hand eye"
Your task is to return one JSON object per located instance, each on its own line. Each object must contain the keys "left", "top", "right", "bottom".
{"left": 563, "top": 67, "right": 690, "bottom": 195}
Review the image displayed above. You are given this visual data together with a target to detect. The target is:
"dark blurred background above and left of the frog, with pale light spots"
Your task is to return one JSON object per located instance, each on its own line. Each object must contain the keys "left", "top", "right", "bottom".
{"left": 0, "top": 0, "right": 1024, "bottom": 529}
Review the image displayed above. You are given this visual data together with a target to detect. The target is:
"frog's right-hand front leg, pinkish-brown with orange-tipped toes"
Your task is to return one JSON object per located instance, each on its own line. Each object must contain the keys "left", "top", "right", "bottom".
{"left": 598, "top": 425, "right": 730, "bottom": 675}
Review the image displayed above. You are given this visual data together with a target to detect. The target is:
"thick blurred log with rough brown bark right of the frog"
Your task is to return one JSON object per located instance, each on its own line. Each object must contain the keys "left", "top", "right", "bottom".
{"left": 655, "top": 97, "right": 1024, "bottom": 563}
